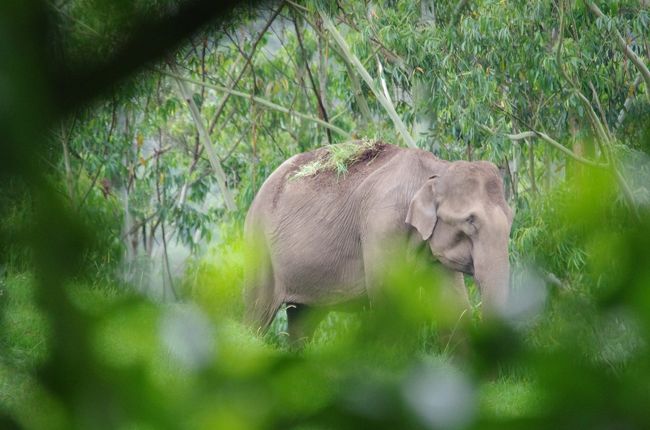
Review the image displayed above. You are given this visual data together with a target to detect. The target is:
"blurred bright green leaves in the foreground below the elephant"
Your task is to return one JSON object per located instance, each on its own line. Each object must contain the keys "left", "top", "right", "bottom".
{"left": 0, "top": 170, "right": 650, "bottom": 428}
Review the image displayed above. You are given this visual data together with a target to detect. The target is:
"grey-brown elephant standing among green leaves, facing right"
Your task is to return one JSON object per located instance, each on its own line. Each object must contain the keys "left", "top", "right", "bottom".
{"left": 244, "top": 141, "right": 513, "bottom": 339}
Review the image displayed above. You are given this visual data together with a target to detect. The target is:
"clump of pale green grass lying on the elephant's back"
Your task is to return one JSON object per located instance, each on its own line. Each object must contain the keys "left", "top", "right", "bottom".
{"left": 292, "top": 139, "right": 381, "bottom": 179}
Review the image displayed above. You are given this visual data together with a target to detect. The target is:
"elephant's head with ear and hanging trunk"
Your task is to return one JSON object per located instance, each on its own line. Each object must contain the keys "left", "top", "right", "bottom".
{"left": 406, "top": 161, "right": 512, "bottom": 312}
